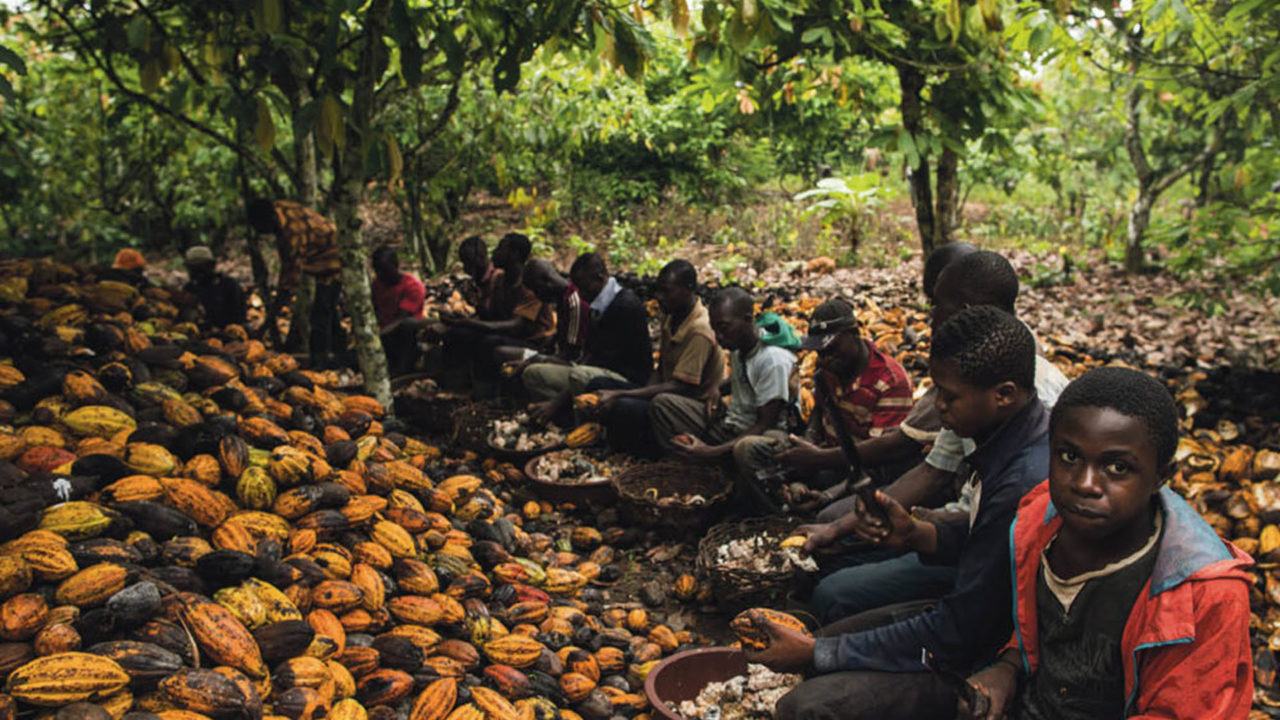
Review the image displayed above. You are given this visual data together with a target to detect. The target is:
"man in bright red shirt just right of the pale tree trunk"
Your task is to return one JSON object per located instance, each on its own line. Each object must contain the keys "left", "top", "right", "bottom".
{"left": 372, "top": 245, "right": 426, "bottom": 377}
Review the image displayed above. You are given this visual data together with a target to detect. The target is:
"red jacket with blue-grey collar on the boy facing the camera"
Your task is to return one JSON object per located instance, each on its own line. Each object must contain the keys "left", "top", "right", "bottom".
{"left": 1007, "top": 480, "right": 1253, "bottom": 720}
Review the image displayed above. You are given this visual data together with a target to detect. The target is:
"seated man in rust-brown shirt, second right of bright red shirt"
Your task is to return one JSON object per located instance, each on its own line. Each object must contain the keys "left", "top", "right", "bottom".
{"left": 442, "top": 233, "right": 556, "bottom": 393}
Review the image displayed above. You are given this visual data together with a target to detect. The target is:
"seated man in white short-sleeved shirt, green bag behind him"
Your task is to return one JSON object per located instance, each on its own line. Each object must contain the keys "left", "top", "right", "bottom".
{"left": 649, "top": 287, "right": 796, "bottom": 460}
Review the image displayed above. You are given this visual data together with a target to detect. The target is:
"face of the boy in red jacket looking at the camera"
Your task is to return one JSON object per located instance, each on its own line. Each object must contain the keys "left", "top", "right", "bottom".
{"left": 1048, "top": 407, "right": 1170, "bottom": 539}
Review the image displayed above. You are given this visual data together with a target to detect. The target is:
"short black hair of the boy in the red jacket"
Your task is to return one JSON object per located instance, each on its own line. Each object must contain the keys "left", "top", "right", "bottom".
{"left": 1048, "top": 366, "right": 1178, "bottom": 466}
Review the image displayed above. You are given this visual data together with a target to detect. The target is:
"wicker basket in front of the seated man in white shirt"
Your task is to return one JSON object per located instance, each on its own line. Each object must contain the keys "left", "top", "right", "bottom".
{"left": 613, "top": 462, "right": 733, "bottom": 532}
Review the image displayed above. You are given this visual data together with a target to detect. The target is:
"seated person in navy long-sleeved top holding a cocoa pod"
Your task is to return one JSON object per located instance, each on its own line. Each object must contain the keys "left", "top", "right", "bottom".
{"left": 748, "top": 306, "right": 1048, "bottom": 720}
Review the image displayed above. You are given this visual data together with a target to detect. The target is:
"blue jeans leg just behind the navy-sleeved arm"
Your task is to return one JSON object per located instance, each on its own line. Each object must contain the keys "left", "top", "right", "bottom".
{"left": 810, "top": 551, "right": 956, "bottom": 623}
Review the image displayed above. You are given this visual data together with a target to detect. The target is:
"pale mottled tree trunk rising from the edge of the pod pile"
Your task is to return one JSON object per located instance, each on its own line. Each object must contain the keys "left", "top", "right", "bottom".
{"left": 329, "top": 0, "right": 392, "bottom": 411}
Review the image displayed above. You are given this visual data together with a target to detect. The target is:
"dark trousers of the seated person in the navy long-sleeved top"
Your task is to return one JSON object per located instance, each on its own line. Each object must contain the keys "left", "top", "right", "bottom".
{"left": 773, "top": 602, "right": 957, "bottom": 720}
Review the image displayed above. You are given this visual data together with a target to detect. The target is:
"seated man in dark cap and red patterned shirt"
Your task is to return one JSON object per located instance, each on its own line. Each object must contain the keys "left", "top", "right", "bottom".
{"left": 733, "top": 299, "right": 914, "bottom": 509}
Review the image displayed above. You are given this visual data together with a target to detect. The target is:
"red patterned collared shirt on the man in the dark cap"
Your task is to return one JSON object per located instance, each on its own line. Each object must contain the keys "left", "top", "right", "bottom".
{"left": 820, "top": 338, "right": 911, "bottom": 443}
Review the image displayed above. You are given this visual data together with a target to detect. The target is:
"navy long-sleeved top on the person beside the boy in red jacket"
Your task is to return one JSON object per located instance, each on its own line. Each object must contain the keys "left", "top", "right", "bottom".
{"left": 814, "top": 397, "right": 1048, "bottom": 673}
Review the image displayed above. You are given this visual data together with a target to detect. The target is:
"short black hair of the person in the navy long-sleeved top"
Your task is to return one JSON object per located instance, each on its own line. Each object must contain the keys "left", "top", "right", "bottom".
{"left": 929, "top": 305, "right": 1036, "bottom": 389}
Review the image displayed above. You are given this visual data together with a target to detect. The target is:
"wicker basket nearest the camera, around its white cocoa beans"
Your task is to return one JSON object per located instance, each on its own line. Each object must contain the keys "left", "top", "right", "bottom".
{"left": 698, "top": 518, "right": 810, "bottom": 612}
